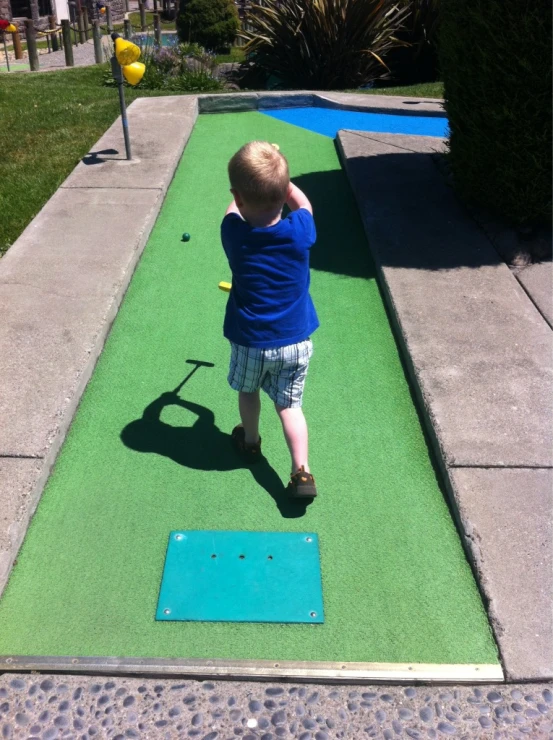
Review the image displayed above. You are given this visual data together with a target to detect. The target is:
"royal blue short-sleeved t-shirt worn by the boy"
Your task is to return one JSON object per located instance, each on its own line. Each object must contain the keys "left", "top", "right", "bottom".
{"left": 221, "top": 208, "right": 319, "bottom": 349}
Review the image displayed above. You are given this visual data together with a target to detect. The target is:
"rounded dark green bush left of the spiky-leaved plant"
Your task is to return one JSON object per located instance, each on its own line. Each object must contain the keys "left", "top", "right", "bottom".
{"left": 177, "top": 0, "right": 239, "bottom": 51}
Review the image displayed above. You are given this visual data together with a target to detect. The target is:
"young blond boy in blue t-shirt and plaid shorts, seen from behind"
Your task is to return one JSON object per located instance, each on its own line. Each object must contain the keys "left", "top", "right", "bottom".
{"left": 221, "top": 141, "right": 319, "bottom": 498}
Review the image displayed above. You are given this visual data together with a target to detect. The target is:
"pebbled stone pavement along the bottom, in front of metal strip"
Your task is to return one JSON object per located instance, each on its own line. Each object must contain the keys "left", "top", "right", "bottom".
{"left": 0, "top": 674, "right": 553, "bottom": 740}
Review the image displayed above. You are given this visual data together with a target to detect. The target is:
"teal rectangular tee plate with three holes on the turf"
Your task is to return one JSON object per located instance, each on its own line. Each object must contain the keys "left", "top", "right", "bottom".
{"left": 156, "top": 531, "right": 324, "bottom": 624}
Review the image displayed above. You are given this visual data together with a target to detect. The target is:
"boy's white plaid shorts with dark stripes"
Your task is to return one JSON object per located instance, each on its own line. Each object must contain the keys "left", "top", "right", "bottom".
{"left": 228, "top": 339, "right": 313, "bottom": 408}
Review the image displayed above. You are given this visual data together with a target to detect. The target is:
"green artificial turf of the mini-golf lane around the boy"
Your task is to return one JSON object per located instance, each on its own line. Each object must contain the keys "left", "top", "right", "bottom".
{"left": 0, "top": 113, "right": 497, "bottom": 663}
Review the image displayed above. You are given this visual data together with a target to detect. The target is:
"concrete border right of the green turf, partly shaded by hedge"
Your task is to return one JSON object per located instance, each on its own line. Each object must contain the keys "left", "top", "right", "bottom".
{"left": 338, "top": 131, "right": 553, "bottom": 681}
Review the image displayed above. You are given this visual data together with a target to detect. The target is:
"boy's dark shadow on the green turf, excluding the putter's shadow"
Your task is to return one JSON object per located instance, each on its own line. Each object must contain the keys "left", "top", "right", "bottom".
{"left": 121, "top": 384, "right": 310, "bottom": 519}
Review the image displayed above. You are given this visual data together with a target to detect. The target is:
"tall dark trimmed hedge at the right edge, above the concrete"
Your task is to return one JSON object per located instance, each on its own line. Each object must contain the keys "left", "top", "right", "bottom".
{"left": 440, "top": 0, "right": 551, "bottom": 225}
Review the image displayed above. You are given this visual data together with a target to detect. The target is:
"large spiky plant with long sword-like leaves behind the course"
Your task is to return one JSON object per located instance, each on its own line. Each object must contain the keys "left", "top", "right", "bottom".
{"left": 241, "top": 0, "right": 408, "bottom": 90}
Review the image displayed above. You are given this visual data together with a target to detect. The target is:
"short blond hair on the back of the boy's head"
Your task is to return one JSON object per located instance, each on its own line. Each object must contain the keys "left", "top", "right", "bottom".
{"left": 228, "top": 141, "right": 290, "bottom": 209}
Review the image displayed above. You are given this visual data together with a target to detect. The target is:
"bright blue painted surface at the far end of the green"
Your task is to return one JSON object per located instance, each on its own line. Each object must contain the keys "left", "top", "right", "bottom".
{"left": 263, "top": 107, "right": 448, "bottom": 139}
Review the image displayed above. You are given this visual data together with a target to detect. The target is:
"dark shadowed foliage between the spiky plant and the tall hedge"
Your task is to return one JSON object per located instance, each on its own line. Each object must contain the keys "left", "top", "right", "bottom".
{"left": 384, "top": 0, "right": 441, "bottom": 85}
